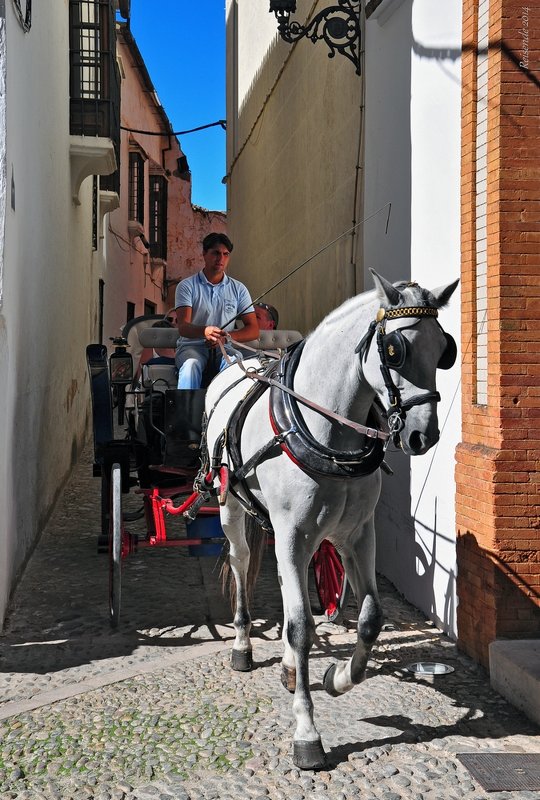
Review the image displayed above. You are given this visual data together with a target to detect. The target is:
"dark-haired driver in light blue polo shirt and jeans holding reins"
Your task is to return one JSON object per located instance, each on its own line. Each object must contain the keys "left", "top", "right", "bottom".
{"left": 175, "top": 233, "right": 259, "bottom": 389}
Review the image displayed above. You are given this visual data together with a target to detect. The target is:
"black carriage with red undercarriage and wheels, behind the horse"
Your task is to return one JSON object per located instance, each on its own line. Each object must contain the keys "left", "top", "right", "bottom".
{"left": 86, "top": 314, "right": 349, "bottom": 627}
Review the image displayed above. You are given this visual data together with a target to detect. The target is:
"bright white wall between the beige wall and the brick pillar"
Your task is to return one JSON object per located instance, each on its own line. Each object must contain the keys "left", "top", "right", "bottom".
{"left": 364, "top": 0, "right": 461, "bottom": 635}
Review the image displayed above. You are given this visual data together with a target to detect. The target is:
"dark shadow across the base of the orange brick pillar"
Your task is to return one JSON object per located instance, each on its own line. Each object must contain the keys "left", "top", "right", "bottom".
{"left": 457, "top": 531, "right": 540, "bottom": 667}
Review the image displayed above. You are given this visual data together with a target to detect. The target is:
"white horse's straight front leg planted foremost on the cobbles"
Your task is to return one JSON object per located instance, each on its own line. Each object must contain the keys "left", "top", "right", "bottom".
{"left": 276, "top": 529, "right": 326, "bottom": 769}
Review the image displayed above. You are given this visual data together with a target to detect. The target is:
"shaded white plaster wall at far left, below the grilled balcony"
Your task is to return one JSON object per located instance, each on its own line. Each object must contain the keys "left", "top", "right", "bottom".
{"left": 0, "top": 3, "right": 101, "bottom": 624}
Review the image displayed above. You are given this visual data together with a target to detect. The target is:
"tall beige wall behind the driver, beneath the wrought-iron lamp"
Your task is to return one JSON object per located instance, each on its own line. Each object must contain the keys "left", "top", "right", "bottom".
{"left": 227, "top": 0, "right": 362, "bottom": 333}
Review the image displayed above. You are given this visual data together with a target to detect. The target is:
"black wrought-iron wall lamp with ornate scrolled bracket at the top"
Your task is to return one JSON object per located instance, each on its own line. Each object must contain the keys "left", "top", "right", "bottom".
{"left": 270, "top": 0, "right": 360, "bottom": 75}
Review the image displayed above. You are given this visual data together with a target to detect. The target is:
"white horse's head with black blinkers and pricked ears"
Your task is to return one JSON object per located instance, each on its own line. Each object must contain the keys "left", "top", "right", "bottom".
{"left": 357, "top": 270, "right": 459, "bottom": 455}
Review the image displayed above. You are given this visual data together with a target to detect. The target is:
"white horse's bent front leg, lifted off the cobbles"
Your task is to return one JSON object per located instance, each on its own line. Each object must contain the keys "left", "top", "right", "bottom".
{"left": 323, "top": 517, "right": 383, "bottom": 697}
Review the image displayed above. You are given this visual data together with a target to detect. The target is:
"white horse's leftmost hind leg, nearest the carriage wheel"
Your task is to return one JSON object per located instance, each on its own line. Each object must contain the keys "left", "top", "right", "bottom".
{"left": 221, "top": 504, "right": 253, "bottom": 672}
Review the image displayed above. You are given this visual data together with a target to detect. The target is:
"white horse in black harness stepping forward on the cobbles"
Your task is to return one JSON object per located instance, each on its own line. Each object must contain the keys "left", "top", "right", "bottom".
{"left": 202, "top": 270, "right": 458, "bottom": 769}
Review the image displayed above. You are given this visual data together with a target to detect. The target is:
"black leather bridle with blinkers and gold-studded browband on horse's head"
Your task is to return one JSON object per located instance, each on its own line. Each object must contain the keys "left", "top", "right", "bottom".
{"left": 354, "top": 306, "right": 457, "bottom": 445}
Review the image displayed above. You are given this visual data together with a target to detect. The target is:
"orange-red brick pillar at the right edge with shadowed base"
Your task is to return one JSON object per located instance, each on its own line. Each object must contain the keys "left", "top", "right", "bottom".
{"left": 456, "top": 0, "right": 540, "bottom": 666}
